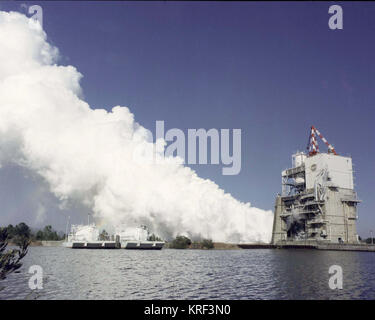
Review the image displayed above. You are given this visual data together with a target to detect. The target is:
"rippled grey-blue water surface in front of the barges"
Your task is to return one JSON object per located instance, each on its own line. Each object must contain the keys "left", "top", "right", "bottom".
{"left": 0, "top": 247, "right": 375, "bottom": 299}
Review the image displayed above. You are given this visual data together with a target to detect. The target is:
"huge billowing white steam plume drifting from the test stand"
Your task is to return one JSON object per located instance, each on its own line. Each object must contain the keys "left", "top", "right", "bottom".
{"left": 0, "top": 11, "right": 273, "bottom": 242}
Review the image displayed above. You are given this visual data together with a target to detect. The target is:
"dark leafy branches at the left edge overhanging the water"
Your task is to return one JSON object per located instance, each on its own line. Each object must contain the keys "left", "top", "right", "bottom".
{"left": 0, "top": 228, "right": 30, "bottom": 280}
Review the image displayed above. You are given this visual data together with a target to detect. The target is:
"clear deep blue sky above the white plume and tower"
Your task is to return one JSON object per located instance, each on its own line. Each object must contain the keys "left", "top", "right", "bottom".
{"left": 0, "top": 1, "right": 375, "bottom": 237}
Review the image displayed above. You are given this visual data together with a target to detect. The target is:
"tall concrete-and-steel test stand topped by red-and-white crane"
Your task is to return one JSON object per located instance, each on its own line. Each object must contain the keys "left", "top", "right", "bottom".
{"left": 272, "top": 126, "right": 360, "bottom": 245}
